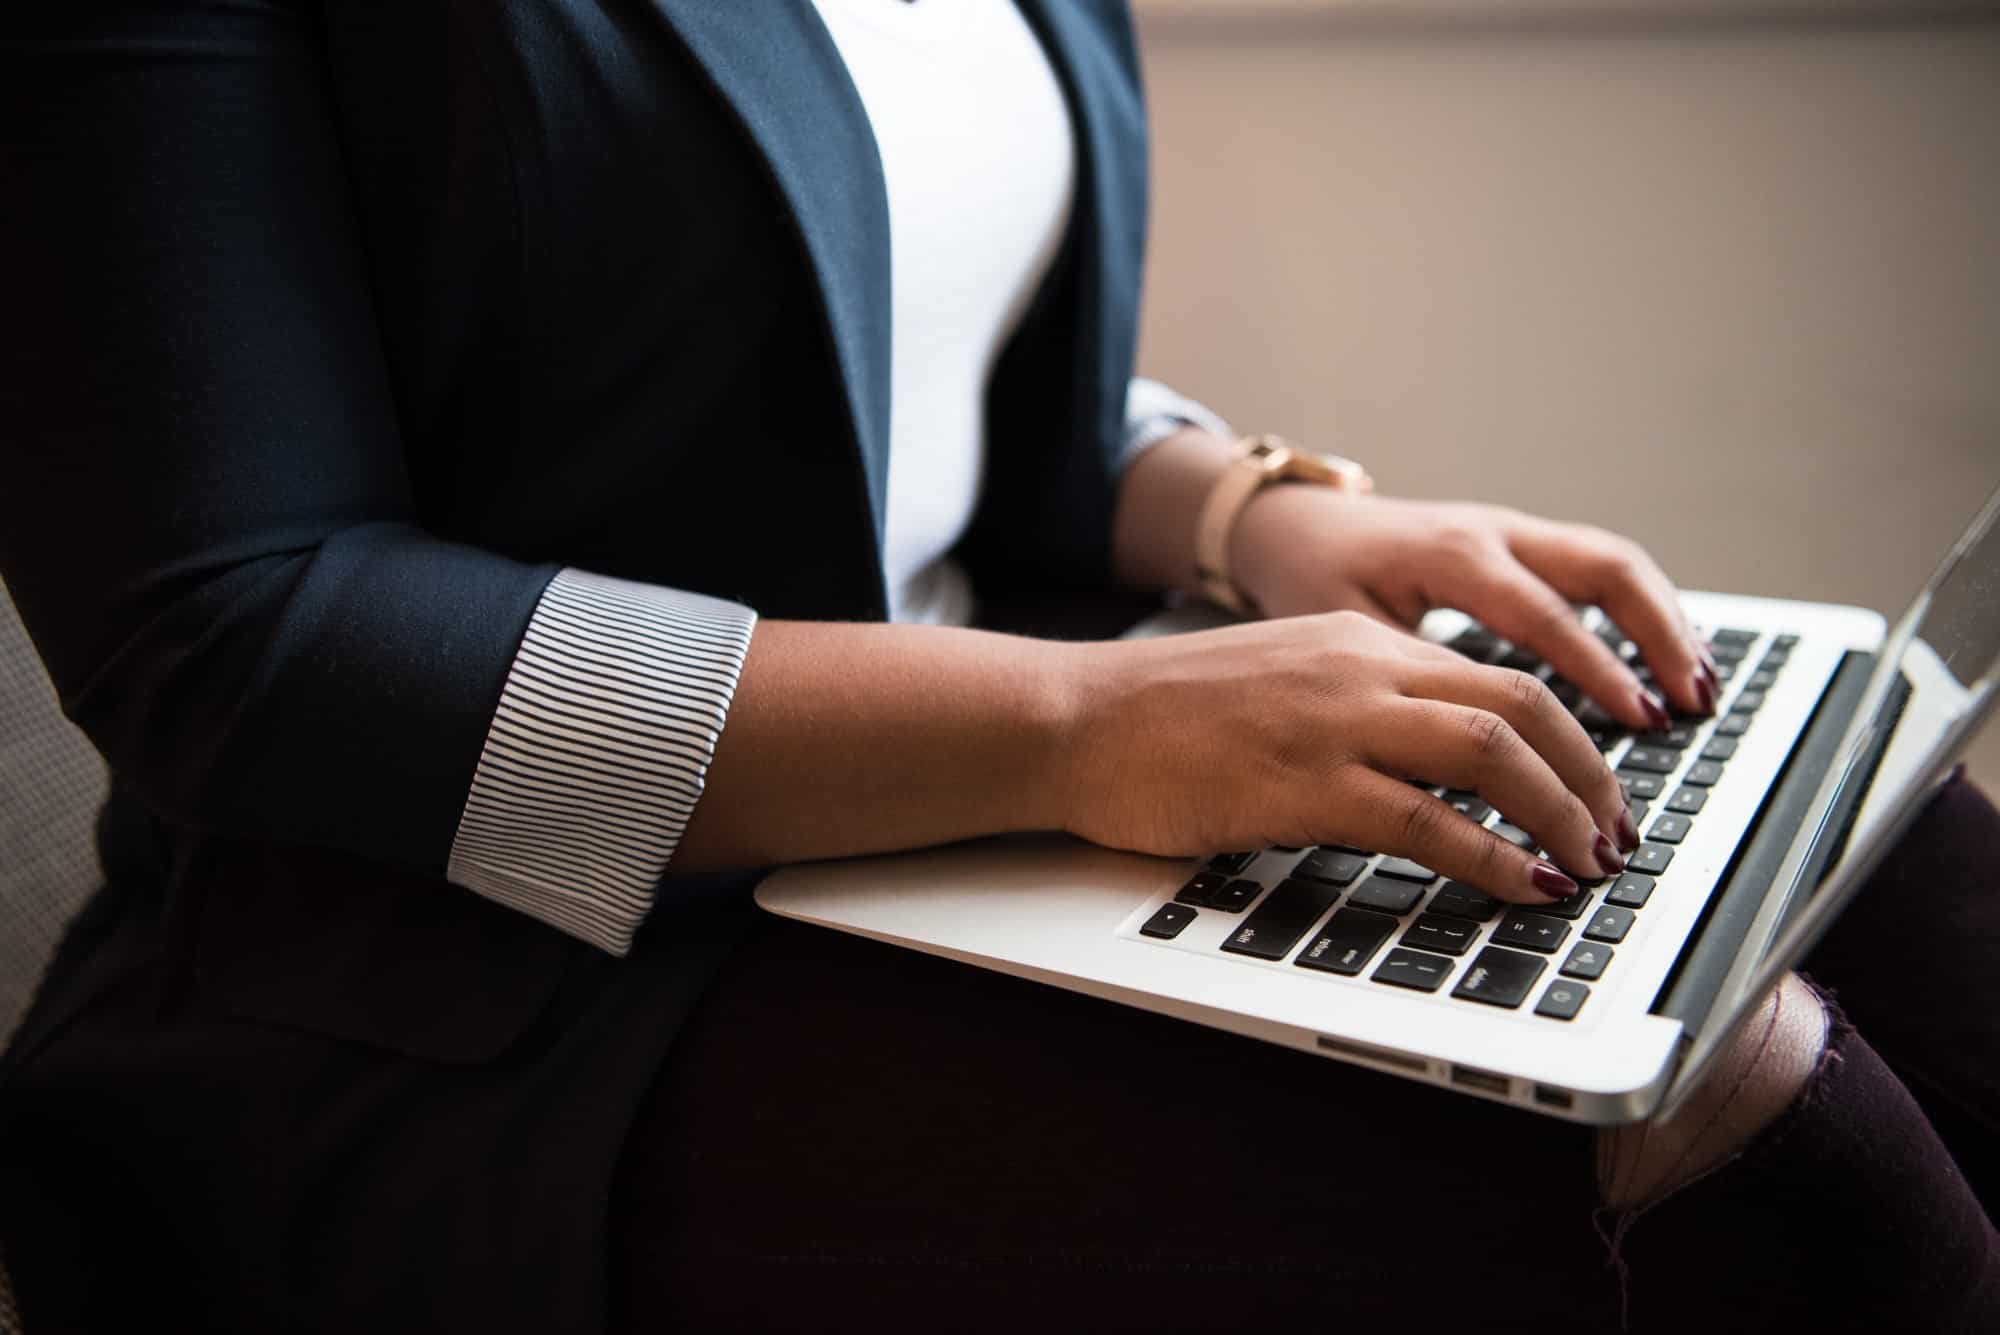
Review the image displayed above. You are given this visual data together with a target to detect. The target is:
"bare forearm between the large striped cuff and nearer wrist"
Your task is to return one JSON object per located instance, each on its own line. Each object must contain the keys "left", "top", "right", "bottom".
{"left": 670, "top": 622, "right": 1078, "bottom": 873}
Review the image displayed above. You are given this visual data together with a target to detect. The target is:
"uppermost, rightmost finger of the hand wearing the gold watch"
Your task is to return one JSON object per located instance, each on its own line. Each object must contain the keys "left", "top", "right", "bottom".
{"left": 1508, "top": 520, "right": 1716, "bottom": 713}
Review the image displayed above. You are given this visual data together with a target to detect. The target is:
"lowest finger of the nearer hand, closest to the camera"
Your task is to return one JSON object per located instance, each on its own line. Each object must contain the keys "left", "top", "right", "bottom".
{"left": 1332, "top": 765, "right": 1576, "bottom": 903}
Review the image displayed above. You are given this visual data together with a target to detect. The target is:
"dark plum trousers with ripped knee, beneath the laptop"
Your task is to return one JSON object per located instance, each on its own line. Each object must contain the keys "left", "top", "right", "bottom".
{"left": 612, "top": 781, "right": 2000, "bottom": 1333}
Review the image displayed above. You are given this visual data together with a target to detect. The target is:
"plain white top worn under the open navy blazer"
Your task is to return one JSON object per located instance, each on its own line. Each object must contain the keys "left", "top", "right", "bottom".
{"left": 814, "top": 0, "right": 1076, "bottom": 624}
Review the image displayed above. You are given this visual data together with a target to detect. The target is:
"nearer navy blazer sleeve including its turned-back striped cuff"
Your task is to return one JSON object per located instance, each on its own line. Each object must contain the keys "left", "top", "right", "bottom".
{"left": 0, "top": 0, "right": 752, "bottom": 951}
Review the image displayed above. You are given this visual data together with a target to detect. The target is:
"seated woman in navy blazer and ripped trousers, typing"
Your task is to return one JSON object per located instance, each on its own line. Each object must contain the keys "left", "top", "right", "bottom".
{"left": 0, "top": 0, "right": 2000, "bottom": 1331}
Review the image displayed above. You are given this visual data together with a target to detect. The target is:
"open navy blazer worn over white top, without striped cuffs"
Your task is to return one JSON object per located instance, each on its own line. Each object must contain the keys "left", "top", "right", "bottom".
{"left": 0, "top": 0, "right": 1146, "bottom": 1329}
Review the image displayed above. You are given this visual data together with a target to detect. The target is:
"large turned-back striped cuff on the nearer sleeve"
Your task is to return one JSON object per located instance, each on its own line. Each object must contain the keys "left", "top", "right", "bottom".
{"left": 446, "top": 570, "right": 756, "bottom": 955}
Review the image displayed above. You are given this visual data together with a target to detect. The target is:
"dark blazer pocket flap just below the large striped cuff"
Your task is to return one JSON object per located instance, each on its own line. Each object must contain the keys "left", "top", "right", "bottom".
{"left": 190, "top": 839, "right": 572, "bottom": 1063}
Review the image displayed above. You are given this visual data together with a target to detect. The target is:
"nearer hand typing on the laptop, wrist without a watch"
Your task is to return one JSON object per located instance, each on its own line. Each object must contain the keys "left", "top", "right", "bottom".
{"left": 1064, "top": 612, "right": 1638, "bottom": 903}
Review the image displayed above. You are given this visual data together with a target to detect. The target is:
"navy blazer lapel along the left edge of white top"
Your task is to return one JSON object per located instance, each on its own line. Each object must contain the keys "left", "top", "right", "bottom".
{"left": 652, "top": 0, "right": 890, "bottom": 554}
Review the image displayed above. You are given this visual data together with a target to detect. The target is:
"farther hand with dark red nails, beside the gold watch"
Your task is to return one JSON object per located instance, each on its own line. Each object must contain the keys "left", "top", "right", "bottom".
{"left": 1230, "top": 484, "right": 1716, "bottom": 729}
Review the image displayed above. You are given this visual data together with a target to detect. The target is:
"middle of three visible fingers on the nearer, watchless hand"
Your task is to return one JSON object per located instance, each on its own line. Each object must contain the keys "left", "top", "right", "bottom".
{"left": 1360, "top": 699, "right": 1624, "bottom": 881}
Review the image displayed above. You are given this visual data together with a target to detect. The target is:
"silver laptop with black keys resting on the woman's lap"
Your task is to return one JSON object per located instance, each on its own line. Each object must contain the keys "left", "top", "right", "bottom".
{"left": 756, "top": 492, "right": 2000, "bottom": 1125}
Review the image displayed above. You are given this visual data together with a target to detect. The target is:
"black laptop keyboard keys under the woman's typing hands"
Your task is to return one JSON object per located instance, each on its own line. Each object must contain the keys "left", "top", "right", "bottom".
{"left": 1140, "top": 620, "right": 1798, "bottom": 1021}
